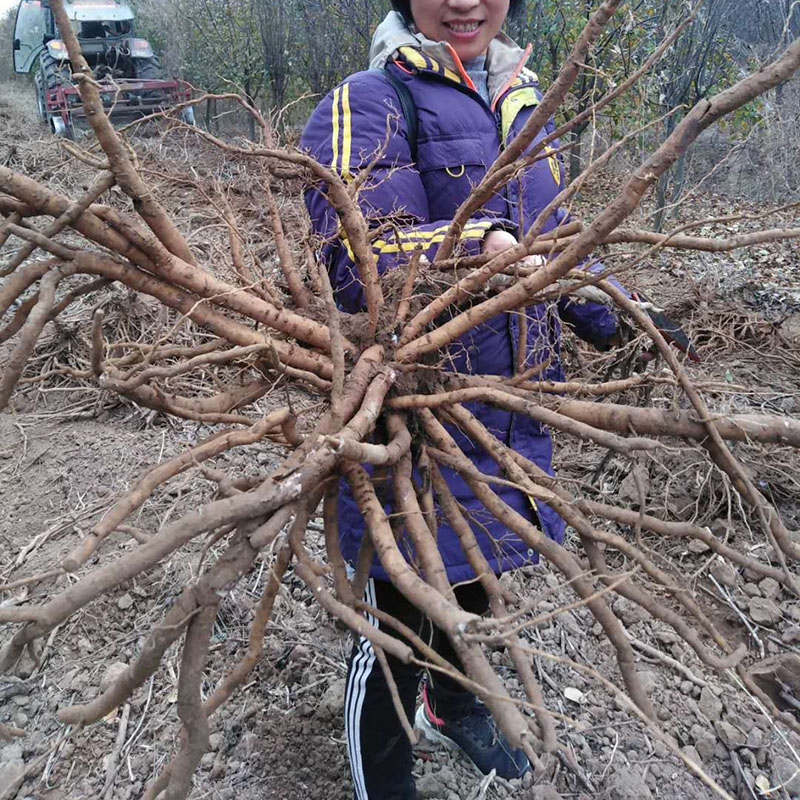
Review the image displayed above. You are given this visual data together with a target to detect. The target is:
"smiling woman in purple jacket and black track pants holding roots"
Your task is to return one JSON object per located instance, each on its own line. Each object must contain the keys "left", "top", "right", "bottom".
{"left": 302, "top": 0, "right": 616, "bottom": 800}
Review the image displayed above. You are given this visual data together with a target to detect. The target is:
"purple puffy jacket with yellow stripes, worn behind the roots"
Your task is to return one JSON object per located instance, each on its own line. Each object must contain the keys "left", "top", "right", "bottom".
{"left": 301, "top": 29, "right": 617, "bottom": 583}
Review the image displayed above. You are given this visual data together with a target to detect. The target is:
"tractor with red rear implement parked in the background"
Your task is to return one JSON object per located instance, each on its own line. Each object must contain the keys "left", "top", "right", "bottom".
{"left": 13, "top": 0, "right": 194, "bottom": 138}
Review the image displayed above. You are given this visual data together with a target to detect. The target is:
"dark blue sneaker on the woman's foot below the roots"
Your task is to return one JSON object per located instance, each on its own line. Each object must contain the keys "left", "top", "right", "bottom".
{"left": 414, "top": 685, "right": 531, "bottom": 780}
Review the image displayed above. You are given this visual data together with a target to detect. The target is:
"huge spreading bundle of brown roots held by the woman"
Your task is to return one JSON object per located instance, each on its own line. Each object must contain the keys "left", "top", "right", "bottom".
{"left": 0, "top": 0, "right": 800, "bottom": 797}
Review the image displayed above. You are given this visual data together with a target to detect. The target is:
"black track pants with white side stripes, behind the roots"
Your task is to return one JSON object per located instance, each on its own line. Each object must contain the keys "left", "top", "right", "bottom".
{"left": 344, "top": 579, "right": 489, "bottom": 800}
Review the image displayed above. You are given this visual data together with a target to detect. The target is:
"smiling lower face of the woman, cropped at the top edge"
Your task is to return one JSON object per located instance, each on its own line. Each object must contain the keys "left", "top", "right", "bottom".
{"left": 411, "top": 0, "right": 509, "bottom": 61}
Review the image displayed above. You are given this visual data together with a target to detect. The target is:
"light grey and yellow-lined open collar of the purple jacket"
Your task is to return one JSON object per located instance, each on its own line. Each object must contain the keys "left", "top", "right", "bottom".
{"left": 369, "top": 11, "right": 537, "bottom": 99}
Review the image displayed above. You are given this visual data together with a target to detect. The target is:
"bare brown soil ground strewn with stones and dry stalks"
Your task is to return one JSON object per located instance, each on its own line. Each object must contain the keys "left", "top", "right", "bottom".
{"left": 0, "top": 86, "right": 800, "bottom": 800}
